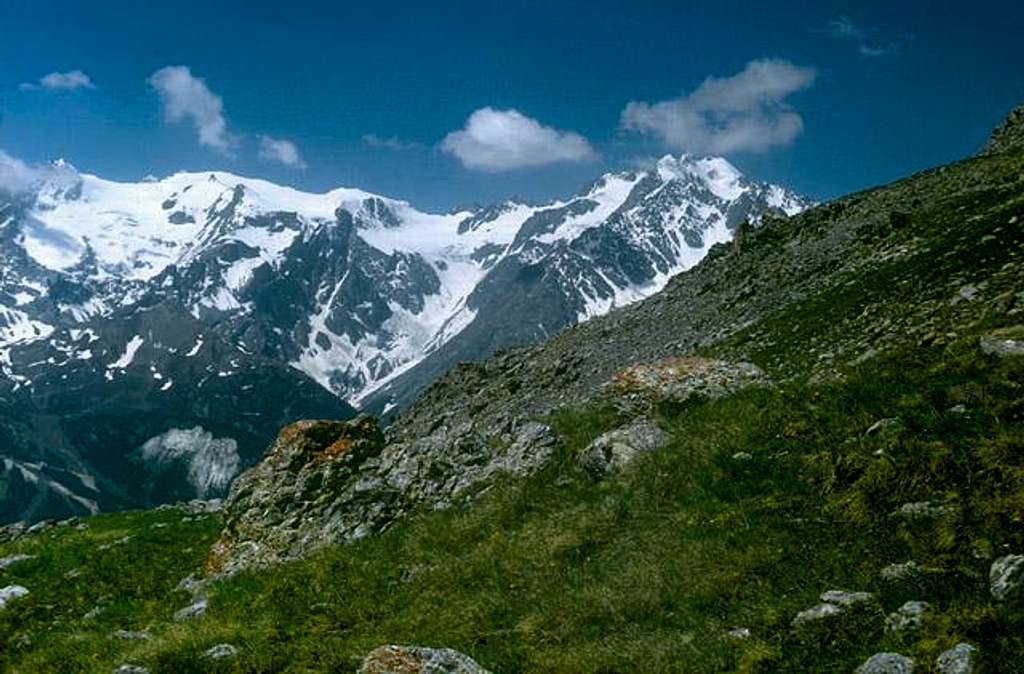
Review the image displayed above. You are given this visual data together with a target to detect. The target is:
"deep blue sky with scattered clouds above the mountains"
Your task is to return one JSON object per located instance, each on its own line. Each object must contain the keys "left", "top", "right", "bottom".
{"left": 0, "top": 0, "right": 1024, "bottom": 211}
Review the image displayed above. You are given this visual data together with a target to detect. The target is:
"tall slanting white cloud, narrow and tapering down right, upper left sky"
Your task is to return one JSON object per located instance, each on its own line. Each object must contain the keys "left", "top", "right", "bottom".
{"left": 147, "top": 66, "right": 238, "bottom": 153}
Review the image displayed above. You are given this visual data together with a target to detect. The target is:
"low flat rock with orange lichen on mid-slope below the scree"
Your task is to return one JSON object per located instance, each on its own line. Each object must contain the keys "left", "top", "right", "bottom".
{"left": 606, "top": 356, "right": 769, "bottom": 409}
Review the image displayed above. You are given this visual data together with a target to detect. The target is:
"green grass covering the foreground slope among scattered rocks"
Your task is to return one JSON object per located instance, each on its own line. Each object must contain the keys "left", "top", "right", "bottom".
{"left": 0, "top": 338, "right": 1024, "bottom": 672}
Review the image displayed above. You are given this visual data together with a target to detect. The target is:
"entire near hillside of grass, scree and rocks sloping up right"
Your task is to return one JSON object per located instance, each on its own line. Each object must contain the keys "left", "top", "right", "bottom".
{"left": 0, "top": 107, "right": 1024, "bottom": 674}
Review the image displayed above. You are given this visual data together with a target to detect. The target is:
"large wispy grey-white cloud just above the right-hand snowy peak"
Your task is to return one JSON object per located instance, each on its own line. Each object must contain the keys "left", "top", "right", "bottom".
{"left": 622, "top": 58, "right": 815, "bottom": 155}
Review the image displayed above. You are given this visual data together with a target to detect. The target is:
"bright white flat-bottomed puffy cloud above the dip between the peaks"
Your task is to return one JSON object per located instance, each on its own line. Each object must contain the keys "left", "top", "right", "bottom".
{"left": 441, "top": 108, "right": 596, "bottom": 171}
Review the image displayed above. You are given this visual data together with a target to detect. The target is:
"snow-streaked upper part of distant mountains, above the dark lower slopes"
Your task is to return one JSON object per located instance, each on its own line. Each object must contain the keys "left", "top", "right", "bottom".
{"left": 0, "top": 155, "right": 805, "bottom": 407}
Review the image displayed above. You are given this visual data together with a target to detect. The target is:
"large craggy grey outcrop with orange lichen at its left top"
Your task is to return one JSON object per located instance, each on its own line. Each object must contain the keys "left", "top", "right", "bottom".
{"left": 207, "top": 415, "right": 555, "bottom": 575}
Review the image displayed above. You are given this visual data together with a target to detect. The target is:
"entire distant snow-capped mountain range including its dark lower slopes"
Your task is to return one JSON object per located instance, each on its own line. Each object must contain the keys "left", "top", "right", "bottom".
{"left": 0, "top": 156, "right": 806, "bottom": 522}
